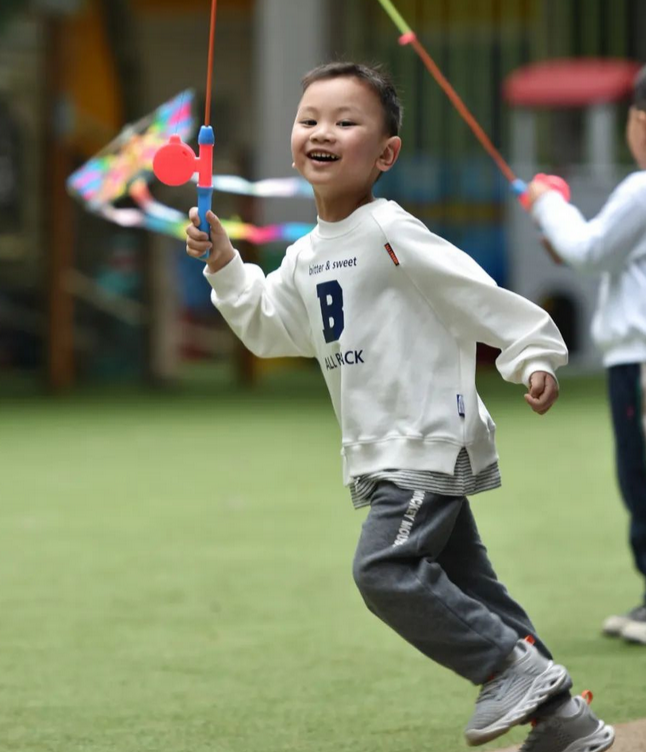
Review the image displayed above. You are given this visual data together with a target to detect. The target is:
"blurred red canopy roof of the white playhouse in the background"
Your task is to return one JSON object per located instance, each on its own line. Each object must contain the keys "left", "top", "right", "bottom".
{"left": 503, "top": 58, "right": 641, "bottom": 107}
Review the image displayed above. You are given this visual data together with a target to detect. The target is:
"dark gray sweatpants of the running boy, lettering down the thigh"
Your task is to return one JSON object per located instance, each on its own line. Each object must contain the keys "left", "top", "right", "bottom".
{"left": 353, "top": 482, "right": 551, "bottom": 684}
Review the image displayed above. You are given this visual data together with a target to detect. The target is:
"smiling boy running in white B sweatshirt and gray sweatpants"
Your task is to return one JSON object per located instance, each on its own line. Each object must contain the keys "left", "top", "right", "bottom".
{"left": 187, "top": 63, "right": 614, "bottom": 752}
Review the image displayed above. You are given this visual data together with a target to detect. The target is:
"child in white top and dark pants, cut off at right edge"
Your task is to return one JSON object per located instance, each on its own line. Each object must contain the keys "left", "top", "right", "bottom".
{"left": 528, "top": 66, "right": 646, "bottom": 645}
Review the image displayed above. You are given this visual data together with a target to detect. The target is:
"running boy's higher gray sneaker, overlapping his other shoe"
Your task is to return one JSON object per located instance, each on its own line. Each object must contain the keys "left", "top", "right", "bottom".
{"left": 464, "top": 640, "right": 571, "bottom": 747}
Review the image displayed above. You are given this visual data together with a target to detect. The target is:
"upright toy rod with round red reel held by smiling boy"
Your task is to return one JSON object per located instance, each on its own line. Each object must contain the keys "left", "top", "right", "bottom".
{"left": 153, "top": 0, "right": 217, "bottom": 259}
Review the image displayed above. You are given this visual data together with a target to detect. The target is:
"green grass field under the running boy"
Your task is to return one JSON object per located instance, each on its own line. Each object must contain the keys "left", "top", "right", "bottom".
{"left": 0, "top": 374, "right": 646, "bottom": 752}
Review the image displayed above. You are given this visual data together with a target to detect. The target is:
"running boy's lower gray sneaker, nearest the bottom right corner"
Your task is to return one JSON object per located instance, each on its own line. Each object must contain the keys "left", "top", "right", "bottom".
{"left": 520, "top": 695, "right": 615, "bottom": 752}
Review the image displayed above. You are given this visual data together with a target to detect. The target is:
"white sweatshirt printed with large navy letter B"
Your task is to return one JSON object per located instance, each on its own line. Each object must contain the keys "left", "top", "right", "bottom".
{"left": 204, "top": 199, "right": 567, "bottom": 485}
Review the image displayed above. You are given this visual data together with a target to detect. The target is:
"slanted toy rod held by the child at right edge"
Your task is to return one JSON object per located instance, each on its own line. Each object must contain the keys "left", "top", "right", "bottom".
{"left": 379, "top": 0, "right": 570, "bottom": 209}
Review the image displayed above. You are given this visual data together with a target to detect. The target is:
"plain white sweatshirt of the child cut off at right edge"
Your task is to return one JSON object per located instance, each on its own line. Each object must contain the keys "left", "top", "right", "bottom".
{"left": 532, "top": 170, "right": 646, "bottom": 367}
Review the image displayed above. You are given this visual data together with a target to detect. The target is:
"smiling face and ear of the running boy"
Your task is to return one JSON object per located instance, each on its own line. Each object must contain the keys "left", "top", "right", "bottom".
{"left": 292, "top": 77, "right": 401, "bottom": 196}
